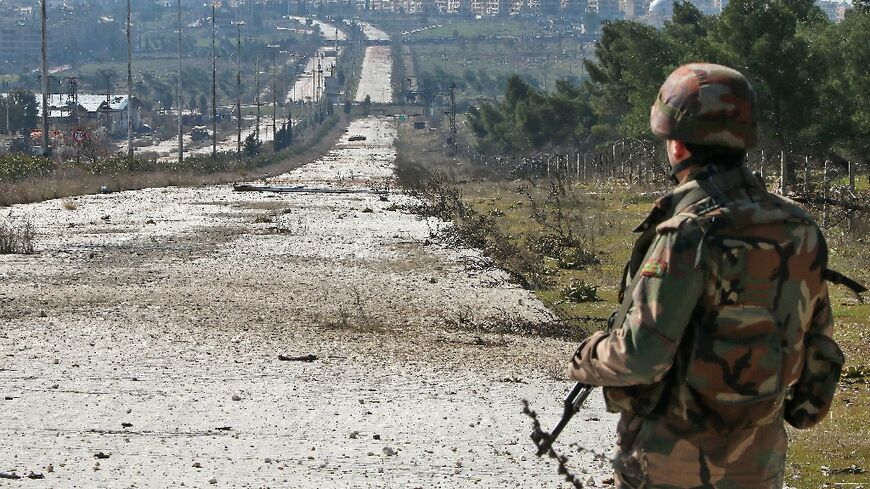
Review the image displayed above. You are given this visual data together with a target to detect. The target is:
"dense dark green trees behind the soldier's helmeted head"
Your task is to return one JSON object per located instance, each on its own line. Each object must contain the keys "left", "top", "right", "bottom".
{"left": 468, "top": 0, "right": 870, "bottom": 168}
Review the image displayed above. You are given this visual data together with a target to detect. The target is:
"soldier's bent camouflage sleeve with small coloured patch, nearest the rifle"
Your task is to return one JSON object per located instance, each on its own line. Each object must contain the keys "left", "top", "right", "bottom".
{"left": 568, "top": 220, "right": 705, "bottom": 386}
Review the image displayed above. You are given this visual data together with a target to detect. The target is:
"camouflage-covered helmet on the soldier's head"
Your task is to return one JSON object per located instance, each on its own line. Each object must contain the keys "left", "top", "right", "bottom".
{"left": 650, "top": 63, "right": 758, "bottom": 149}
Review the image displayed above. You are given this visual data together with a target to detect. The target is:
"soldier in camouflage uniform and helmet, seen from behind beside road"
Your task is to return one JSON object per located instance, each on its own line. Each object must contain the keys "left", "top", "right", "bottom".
{"left": 569, "top": 64, "right": 844, "bottom": 489}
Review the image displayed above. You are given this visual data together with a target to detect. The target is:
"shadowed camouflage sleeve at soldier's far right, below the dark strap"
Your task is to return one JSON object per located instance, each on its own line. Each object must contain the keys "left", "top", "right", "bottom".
{"left": 784, "top": 285, "right": 845, "bottom": 429}
